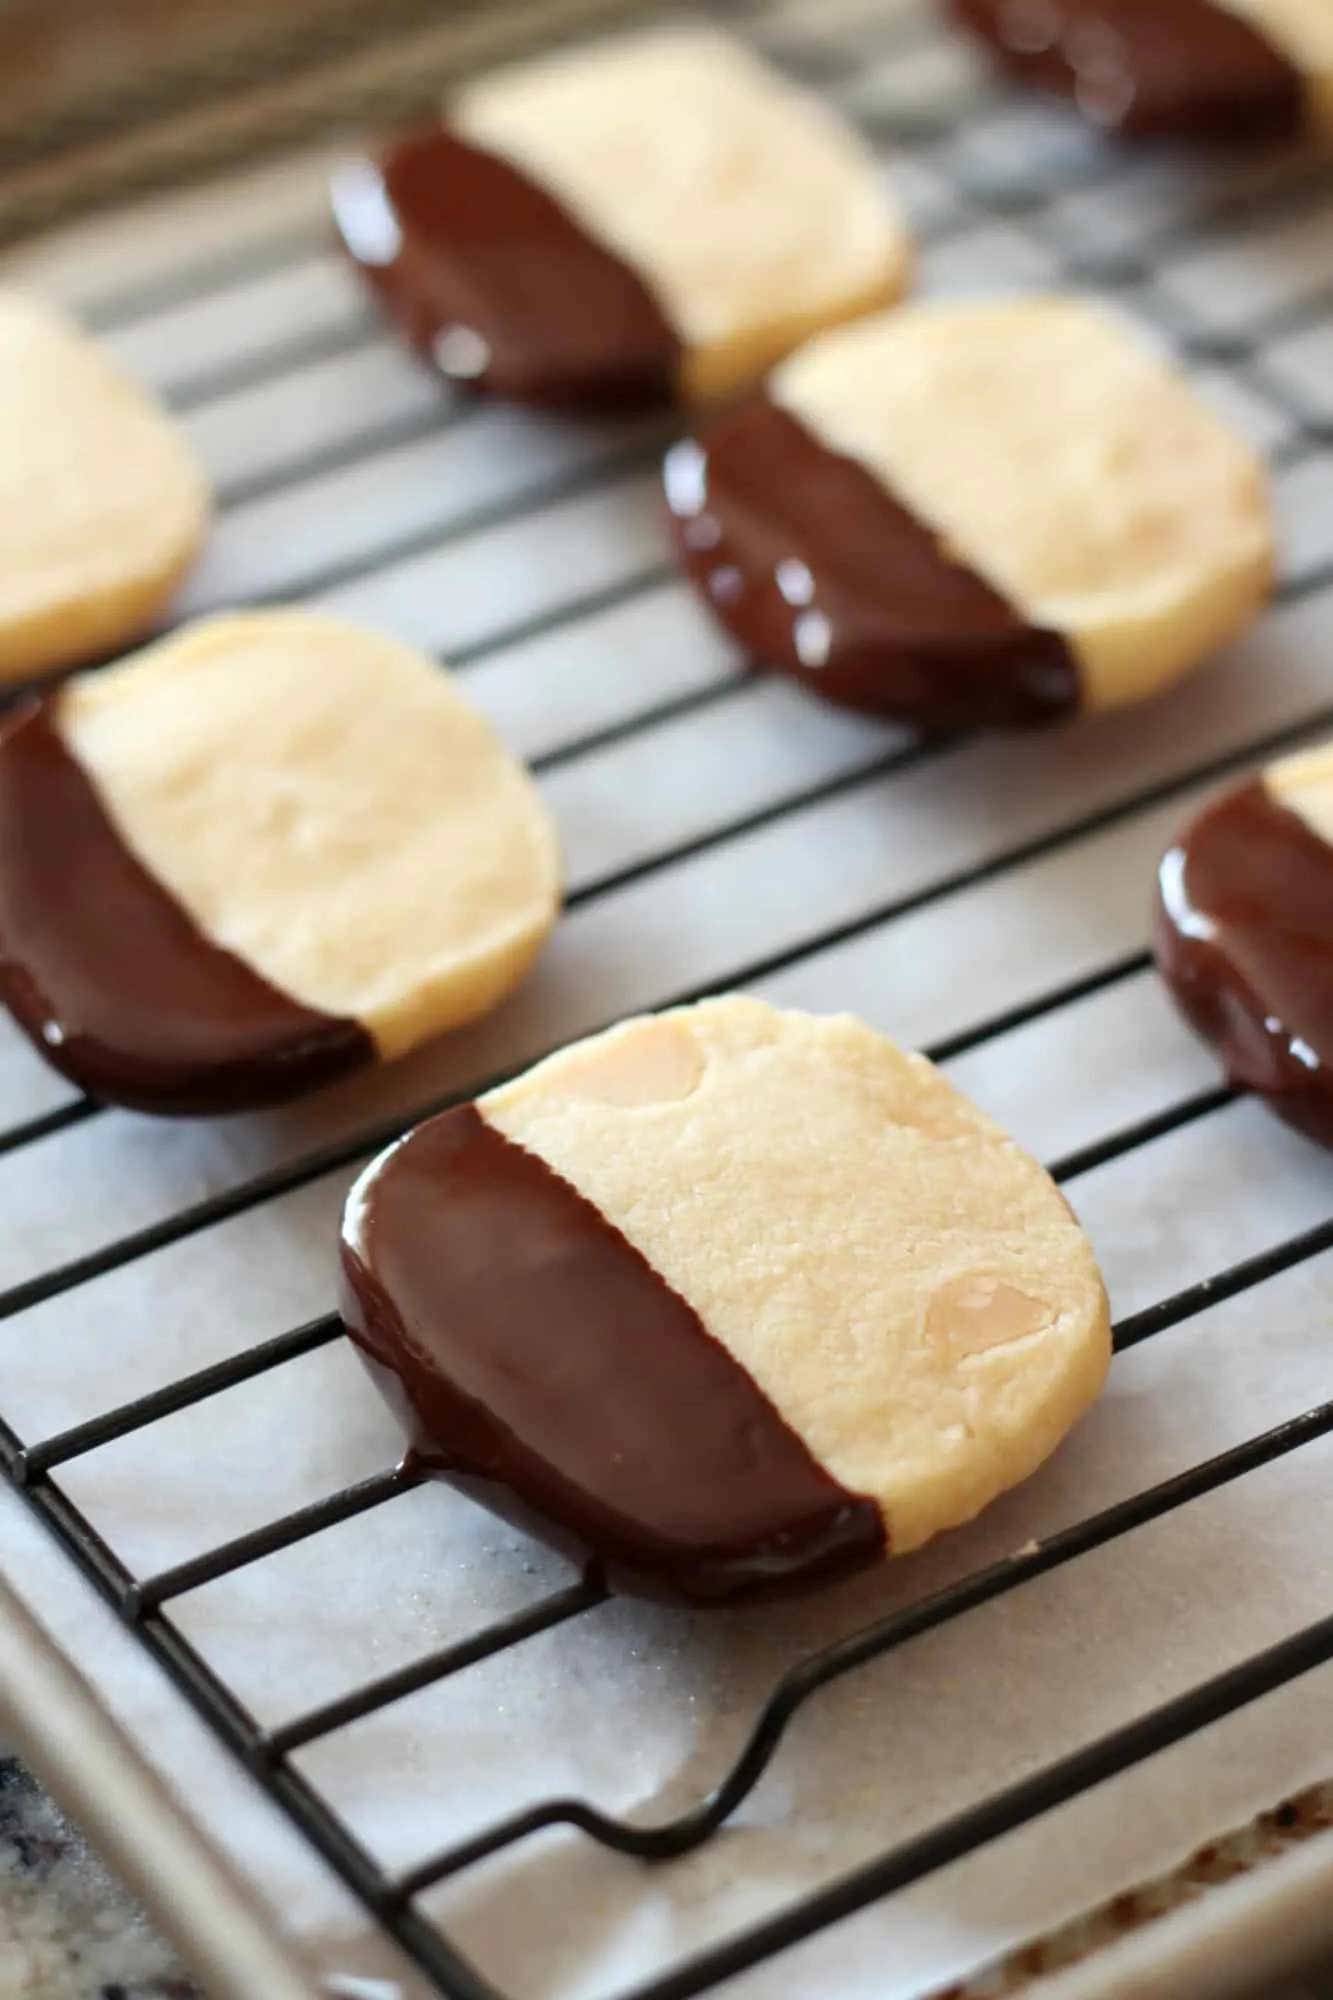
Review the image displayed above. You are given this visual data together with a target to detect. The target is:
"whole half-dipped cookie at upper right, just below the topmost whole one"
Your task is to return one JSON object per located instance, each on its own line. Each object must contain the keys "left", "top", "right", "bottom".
{"left": 667, "top": 296, "right": 1273, "bottom": 728}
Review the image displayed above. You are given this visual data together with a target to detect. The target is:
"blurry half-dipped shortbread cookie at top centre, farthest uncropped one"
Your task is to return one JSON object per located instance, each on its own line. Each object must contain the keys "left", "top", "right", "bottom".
{"left": 334, "top": 28, "right": 909, "bottom": 402}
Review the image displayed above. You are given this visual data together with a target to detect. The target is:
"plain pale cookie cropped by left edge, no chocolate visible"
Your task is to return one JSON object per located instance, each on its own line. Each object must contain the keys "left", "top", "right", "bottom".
{"left": 0, "top": 292, "right": 208, "bottom": 680}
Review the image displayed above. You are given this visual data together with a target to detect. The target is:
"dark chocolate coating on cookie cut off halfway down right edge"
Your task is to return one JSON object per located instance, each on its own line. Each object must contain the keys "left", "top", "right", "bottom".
{"left": 1155, "top": 782, "right": 1333, "bottom": 1146}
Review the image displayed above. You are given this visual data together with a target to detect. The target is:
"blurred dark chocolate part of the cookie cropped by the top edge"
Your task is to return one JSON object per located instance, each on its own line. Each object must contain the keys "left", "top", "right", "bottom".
{"left": 949, "top": 0, "right": 1305, "bottom": 140}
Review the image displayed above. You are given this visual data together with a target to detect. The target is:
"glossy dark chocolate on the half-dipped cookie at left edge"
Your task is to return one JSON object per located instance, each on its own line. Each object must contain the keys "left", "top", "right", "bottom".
{"left": 0, "top": 702, "right": 374, "bottom": 1114}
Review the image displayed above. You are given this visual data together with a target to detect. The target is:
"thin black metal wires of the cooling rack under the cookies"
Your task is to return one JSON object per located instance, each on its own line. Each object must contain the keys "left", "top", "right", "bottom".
{"left": 0, "top": 0, "right": 1333, "bottom": 2000}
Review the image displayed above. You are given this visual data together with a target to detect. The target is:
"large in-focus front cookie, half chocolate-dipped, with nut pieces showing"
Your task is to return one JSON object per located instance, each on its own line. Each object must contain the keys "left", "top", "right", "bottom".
{"left": 342, "top": 998, "right": 1111, "bottom": 1602}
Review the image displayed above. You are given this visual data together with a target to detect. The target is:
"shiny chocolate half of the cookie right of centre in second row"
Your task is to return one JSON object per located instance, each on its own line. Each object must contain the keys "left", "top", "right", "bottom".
{"left": 667, "top": 396, "right": 1079, "bottom": 730}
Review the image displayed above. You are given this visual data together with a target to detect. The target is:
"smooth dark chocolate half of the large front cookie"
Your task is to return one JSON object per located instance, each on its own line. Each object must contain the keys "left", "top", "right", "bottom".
{"left": 342, "top": 1104, "right": 885, "bottom": 1604}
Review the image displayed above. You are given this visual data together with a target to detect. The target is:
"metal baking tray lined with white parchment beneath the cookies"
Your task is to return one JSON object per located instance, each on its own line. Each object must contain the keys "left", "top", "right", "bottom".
{"left": 0, "top": 0, "right": 1333, "bottom": 2000}
